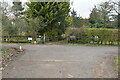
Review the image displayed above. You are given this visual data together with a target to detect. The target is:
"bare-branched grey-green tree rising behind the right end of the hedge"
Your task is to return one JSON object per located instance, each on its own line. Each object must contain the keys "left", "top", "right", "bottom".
{"left": 89, "top": 1, "right": 117, "bottom": 28}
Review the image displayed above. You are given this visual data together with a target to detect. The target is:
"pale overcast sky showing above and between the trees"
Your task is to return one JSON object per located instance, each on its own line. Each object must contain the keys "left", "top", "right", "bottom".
{"left": 3, "top": 0, "right": 118, "bottom": 18}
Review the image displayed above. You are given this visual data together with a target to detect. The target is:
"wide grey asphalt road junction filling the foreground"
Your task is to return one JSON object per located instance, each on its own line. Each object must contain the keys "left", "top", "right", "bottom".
{"left": 3, "top": 45, "right": 118, "bottom": 78}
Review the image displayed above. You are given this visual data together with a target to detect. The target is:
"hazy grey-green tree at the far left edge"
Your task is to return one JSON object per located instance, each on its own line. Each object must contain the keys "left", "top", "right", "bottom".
{"left": 2, "top": 2, "right": 16, "bottom": 37}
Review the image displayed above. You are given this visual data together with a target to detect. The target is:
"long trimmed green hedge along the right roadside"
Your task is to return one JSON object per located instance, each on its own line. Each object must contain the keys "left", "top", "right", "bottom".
{"left": 66, "top": 28, "right": 119, "bottom": 44}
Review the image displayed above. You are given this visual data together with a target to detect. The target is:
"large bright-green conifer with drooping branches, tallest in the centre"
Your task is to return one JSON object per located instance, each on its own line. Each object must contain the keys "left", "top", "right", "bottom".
{"left": 25, "top": 2, "right": 70, "bottom": 39}
